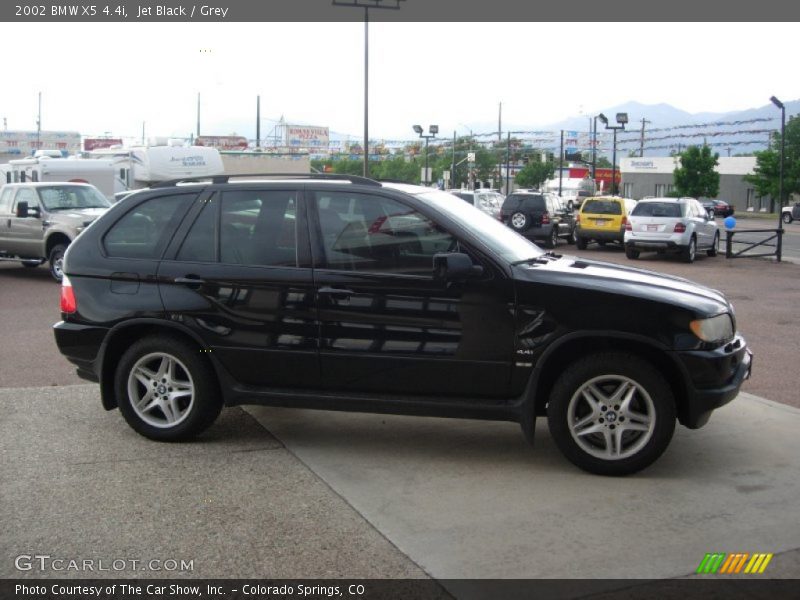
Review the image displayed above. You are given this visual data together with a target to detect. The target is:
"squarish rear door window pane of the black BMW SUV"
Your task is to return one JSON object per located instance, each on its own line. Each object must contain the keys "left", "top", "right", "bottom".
{"left": 220, "top": 190, "right": 297, "bottom": 267}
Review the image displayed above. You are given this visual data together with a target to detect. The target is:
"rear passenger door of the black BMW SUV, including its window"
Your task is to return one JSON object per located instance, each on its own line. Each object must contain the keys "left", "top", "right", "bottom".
{"left": 158, "top": 186, "right": 319, "bottom": 388}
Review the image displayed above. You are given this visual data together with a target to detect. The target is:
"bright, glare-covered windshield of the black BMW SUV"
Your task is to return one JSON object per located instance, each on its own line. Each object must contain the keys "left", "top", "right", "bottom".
{"left": 419, "top": 190, "right": 544, "bottom": 262}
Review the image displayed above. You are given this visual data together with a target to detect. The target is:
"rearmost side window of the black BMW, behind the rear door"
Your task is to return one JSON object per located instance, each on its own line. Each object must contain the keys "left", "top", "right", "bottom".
{"left": 103, "top": 194, "right": 196, "bottom": 259}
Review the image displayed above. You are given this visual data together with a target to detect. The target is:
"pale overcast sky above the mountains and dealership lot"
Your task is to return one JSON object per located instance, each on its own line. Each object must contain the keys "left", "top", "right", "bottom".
{"left": 0, "top": 22, "right": 800, "bottom": 139}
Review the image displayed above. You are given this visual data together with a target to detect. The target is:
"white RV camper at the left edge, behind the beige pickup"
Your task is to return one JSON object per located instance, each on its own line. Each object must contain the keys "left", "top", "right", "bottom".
{"left": 3, "top": 151, "right": 115, "bottom": 200}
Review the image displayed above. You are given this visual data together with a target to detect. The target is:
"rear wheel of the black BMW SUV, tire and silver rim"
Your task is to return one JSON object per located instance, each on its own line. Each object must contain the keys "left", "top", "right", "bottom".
{"left": 114, "top": 335, "right": 222, "bottom": 442}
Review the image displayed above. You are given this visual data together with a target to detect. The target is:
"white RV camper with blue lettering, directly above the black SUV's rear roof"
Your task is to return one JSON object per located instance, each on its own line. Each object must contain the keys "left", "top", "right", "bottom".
{"left": 84, "top": 138, "right": 225, "bottom": 192}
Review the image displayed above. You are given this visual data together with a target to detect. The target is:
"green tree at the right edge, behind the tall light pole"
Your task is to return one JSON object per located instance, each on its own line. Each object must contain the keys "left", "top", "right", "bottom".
{"left": 744, "top": 117, "right": 800, "bottom": 205}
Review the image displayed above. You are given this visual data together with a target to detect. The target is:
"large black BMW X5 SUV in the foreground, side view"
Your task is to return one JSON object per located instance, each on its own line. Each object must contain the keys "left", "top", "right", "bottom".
{"left": 55, "top": 176, "right": 750, "bottom": 475}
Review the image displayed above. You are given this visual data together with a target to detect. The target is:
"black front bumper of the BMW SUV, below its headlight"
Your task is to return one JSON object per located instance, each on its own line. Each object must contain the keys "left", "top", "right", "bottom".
{"left": 678, "top": 336, "right": 753, "bottom": 429}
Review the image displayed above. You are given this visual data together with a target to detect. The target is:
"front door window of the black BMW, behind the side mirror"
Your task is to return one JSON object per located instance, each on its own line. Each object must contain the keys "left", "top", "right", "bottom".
{"left": 317, "top": 192, "right": 455, "bottom": 276}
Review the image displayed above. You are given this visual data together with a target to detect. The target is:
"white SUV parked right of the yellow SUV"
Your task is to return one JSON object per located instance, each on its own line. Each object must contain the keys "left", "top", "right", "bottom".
{"left": 625, "top": 198, "right": 719, "bottom": 263}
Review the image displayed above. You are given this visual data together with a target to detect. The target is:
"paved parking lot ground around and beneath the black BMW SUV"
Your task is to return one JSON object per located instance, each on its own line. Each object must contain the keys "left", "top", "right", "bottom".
{"left": 0, "top": 224, "right": 800, "bottom": 595}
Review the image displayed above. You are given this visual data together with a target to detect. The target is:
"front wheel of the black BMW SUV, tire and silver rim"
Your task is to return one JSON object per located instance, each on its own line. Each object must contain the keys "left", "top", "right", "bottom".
{"left": 547, "top": 352, "right": 676, "bottom": 475}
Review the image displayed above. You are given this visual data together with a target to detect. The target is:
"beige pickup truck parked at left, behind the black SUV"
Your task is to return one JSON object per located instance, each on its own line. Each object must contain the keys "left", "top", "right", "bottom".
{"left": 0, "top": 182, "right": 111, "bottom": 281}
